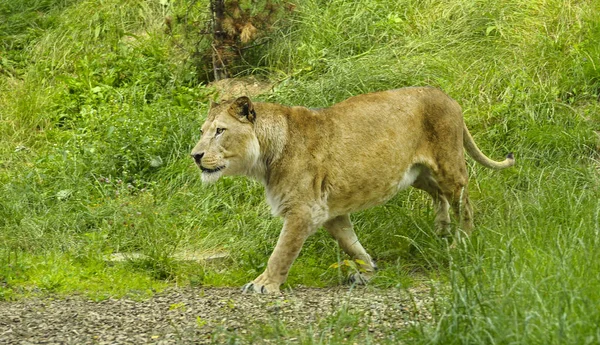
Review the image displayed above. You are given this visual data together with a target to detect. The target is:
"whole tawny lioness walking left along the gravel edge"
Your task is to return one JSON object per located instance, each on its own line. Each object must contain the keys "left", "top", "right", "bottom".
{"left": 192, "top": 87, "right": 514, "bottom": 293}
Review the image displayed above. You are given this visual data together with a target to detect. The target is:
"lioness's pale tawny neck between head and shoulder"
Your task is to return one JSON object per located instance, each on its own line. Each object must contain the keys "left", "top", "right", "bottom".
{"left": 250, "top": 110, "right": 288, "bottom": 186}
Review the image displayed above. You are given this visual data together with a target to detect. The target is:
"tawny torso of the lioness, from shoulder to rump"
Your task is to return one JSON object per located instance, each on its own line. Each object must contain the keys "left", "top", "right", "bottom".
{"left": 248, "top": 88, "right": 463, "bottom": 218}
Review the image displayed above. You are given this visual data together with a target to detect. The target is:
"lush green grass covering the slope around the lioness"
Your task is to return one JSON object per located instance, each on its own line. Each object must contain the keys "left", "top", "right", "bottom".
{"left": 0, "top": 0, "right": 600, "bottom": 344}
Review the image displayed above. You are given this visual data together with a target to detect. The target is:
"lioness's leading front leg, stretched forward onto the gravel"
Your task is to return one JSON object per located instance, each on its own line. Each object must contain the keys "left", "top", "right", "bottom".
{"left": 242, "top": 213, "right": 316, "bottom": 294}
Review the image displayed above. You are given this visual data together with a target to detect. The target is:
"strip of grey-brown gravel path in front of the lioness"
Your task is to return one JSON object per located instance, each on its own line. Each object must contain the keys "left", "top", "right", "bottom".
{"left": 0, "top": 287, "right": 432, "bottom": 344}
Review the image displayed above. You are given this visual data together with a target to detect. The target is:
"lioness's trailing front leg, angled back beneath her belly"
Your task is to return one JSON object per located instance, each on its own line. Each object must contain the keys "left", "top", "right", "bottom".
{"left": 323, "top": 214, "right": 377, "bottom": 285}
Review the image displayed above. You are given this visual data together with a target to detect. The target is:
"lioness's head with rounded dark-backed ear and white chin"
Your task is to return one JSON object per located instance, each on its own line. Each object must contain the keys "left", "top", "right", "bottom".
{"left": 192, "top": 97, "right": 260, "bottom": 183}
